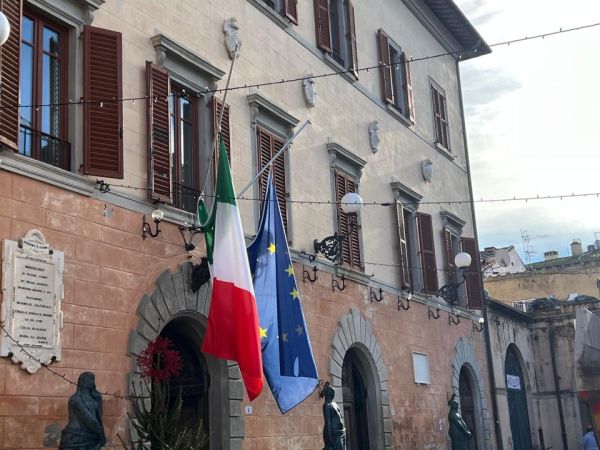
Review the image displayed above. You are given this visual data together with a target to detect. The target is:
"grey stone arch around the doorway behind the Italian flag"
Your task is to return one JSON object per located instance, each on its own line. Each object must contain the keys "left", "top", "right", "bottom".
{"left": 128, "top": 262, "right": 244, "bottom": 450}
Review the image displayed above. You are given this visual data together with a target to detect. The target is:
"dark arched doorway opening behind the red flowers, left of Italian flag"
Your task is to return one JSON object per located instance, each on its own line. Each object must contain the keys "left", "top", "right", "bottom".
{"left": 160, "top": 318, "right": 210, "bottom": 436}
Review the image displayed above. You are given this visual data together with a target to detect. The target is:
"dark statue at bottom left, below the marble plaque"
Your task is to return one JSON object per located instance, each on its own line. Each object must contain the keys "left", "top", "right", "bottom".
{"left": 58, "top": 372, "right": 106, "bottom": 450}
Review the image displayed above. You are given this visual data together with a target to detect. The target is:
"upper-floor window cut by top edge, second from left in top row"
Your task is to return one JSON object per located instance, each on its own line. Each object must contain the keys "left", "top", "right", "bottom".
{"left": 315, "top": 0, "right": 358, "bottom": 77}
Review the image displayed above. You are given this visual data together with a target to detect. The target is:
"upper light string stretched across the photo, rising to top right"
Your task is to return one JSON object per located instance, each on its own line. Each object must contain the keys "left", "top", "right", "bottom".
{"left": 0, "top": 22, "right": 600, "bottom": 110}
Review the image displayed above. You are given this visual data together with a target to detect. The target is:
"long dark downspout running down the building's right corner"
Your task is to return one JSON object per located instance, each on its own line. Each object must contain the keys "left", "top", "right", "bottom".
{"left": 455, "top": 60, "right": 504, "bottom": 450}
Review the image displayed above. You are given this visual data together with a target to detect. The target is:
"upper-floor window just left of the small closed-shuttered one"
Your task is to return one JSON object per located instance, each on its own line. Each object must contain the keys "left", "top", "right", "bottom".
{"left": 378, "top": 29, "right": 415, "bottom": 123}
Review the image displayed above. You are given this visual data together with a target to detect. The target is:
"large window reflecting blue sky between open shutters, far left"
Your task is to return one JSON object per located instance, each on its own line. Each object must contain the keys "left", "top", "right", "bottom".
{"left": 19, "top": 12, "right": 71, "bottom": 170}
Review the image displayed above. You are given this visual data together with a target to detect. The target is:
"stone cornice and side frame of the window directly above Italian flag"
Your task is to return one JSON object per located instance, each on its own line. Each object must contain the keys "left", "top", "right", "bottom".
{"left": 150, "top": 33, "right": 225, "bottom": 205}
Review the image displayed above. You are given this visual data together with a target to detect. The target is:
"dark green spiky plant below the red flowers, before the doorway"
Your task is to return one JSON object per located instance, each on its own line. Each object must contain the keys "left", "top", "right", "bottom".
{"left": 130, "top": 380, "right": 208, "bottom": 450}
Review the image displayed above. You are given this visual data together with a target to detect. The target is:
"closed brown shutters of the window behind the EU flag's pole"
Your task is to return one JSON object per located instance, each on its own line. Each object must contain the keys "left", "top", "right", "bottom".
{"left": 256, "top": 127, "right": 289, "bottom": 235}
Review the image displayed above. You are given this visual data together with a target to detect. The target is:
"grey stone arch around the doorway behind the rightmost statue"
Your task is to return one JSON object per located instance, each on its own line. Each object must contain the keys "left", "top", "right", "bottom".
{"left": 450, "top": 337, "right": 491, "bottom": 448}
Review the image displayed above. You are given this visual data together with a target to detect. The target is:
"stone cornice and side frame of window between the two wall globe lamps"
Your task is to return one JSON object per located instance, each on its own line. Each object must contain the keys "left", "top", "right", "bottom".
{"left": 390, "top": 180, "right": 423, "bottom": 292}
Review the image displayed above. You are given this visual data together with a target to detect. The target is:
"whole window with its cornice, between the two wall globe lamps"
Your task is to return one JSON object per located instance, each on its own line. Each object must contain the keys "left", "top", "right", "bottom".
{"left": 391, "top": 181, "right": 423, "bottom": 291}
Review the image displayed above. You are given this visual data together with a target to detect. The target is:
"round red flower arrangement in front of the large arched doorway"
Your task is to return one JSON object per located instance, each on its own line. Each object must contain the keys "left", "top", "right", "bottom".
{"left": 137, "top": 336, "right": 183, "bottom": 383}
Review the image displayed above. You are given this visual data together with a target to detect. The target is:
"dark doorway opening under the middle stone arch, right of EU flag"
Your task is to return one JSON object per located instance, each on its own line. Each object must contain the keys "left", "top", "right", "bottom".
{"left": 342, "top": 348, "right": 370, "bottom": 450}
